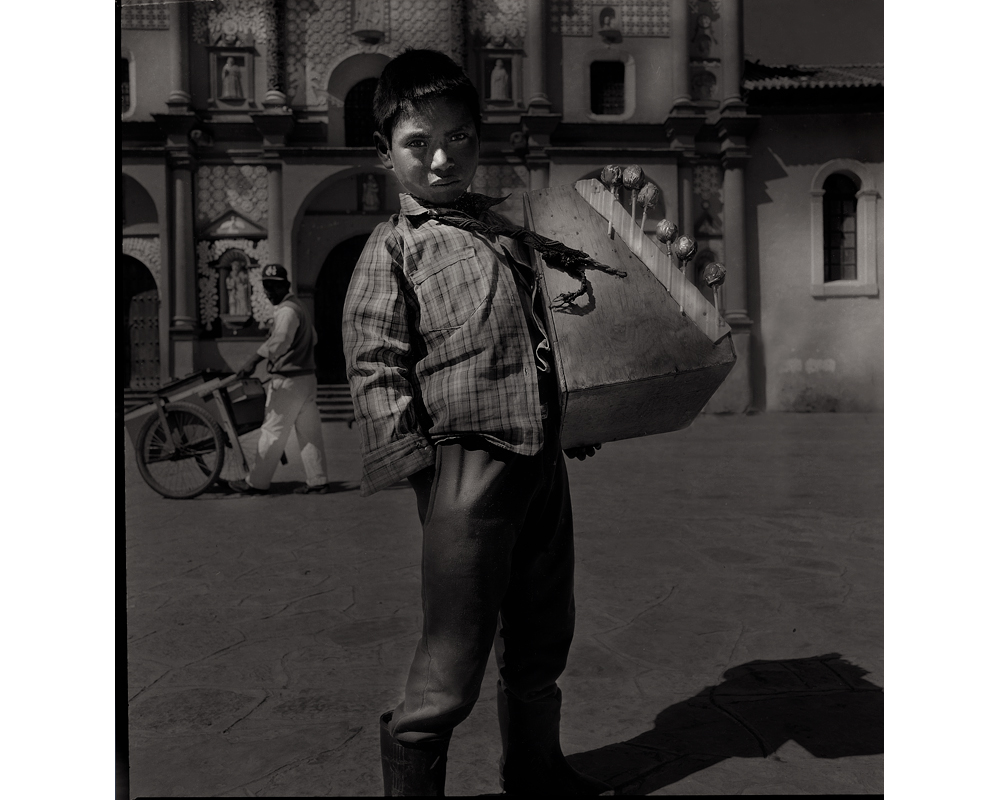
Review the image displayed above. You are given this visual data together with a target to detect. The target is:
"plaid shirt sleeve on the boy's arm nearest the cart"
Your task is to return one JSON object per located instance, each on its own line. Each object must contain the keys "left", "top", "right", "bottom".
{"left": 343, "top": 222, "right": 434, "bottom": 497}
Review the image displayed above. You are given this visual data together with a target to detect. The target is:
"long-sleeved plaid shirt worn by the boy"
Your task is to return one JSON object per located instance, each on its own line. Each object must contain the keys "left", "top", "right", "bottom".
{"left": 344, "top": 194, "right": 548, "bottom": 496}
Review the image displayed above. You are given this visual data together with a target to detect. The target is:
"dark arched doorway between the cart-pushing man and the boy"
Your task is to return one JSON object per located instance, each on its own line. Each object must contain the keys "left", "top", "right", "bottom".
{"left": 313, "top": 233, "right": 369, "bottom": 383}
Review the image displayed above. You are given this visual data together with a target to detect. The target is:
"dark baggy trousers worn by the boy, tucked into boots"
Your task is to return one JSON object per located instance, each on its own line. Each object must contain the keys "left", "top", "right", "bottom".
{"left": 390, "top": 429, "right": 575, "bottom": 743}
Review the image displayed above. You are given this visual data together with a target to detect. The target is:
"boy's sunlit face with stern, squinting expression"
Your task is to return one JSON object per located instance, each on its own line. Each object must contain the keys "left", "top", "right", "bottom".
{"left": 375, "top": 98, "right": 479, "bottom": 203}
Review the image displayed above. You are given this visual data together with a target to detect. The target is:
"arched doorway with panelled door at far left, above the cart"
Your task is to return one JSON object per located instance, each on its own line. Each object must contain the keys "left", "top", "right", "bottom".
{"left": 118, "top": 255, "right": 160, "bottom": 389}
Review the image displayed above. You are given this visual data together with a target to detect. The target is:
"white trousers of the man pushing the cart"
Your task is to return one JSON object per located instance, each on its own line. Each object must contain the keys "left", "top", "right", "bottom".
{"left": 247, "top": 375, "right": 327, "bottom": 489}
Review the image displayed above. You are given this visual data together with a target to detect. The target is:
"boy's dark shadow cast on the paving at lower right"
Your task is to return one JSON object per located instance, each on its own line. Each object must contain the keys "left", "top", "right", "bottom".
{"left": 567, "top": 653, "right": 883, "bottom": 795}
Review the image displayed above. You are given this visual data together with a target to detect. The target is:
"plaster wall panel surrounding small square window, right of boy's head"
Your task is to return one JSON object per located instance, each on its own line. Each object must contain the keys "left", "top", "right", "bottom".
{"left": 564, "top": 36, "right": 674, "bottom": 123}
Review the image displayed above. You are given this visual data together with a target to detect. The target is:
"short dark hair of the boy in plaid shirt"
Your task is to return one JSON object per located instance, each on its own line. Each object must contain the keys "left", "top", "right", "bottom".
{"left": 372, "top": 50, "right": 482, "bottom": 144}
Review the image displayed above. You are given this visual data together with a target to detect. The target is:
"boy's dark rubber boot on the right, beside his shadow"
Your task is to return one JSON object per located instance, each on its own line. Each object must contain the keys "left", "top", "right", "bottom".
{"left": 497, "top": 683, "right": 614, "bottom": 797}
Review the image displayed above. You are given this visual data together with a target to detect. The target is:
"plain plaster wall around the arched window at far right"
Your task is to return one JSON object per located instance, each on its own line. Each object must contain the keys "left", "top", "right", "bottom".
{"left": 747, "top": 114, "right": 884, "bottom": 411}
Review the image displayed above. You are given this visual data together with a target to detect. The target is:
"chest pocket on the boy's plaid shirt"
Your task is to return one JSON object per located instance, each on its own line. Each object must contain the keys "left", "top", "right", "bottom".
{"left": 411, "top": 245, "right": 489, "bottom": 333}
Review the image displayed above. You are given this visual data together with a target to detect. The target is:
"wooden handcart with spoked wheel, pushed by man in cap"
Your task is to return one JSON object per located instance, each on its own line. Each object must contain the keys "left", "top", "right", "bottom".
{"left": 125, "top": 372, "right": 274, "bottom": 498}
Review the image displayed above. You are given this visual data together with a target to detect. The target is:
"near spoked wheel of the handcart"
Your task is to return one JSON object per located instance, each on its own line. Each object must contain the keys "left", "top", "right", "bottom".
{"left": 135, "top": 403, "right": 225, "bottom": 498}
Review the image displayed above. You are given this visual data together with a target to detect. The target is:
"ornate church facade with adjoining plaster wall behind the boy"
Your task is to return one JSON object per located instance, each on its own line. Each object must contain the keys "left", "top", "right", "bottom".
{"left": 119, "top": 0, "right": 883, "bottom": 412}
